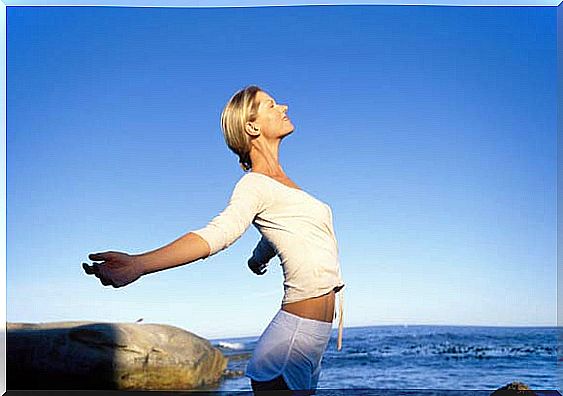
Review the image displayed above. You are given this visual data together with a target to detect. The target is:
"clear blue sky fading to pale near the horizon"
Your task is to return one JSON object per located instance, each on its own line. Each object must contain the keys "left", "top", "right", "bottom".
{"left": 6, "top": 6, "right": 557, "bottom": 338}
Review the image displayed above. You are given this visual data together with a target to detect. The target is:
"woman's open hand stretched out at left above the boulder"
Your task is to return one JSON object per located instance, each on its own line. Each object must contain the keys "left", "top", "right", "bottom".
{"left": 82, "top": 252, "right": 147, "bottom": 288}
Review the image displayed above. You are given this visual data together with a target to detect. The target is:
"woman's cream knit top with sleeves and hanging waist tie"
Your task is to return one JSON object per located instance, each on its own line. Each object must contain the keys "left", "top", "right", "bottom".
{"left": 192, "top": 172, "right": 344, "bottom": 346}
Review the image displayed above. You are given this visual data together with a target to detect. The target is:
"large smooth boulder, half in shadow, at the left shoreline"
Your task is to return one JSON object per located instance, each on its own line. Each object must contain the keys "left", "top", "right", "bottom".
{"left": 6, "top": 322, "right": 228, "bottom": 390}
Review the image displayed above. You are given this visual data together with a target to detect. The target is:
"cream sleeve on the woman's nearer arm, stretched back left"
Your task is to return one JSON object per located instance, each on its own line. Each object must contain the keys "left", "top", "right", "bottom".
{"left": 192, "top": 178, "right": 265, "bottom": 257}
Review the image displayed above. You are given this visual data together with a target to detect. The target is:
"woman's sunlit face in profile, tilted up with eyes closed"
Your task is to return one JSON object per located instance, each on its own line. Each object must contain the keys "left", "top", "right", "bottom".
{"left": 253, "top": 91, "right": 294, "bottom": 138}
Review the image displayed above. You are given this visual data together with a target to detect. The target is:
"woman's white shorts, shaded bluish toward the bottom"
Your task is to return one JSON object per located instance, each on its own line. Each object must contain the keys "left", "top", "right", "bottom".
{"left": 246, "top": 309, "right": 332, "bottom": 390}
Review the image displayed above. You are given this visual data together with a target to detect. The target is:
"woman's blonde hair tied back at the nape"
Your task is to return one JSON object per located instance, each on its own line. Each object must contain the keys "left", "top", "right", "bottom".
{"left": 221, "top": 85, "right": 263, "bottom": 172}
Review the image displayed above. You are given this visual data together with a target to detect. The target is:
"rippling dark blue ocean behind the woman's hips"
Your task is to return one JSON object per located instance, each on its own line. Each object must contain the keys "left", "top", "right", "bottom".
{"left": 210, "top": 325, "right": 563, "bottom": 394}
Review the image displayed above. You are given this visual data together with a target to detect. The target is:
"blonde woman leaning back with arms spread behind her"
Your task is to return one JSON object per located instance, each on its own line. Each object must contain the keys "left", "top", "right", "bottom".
{"left": 83, "top": 86, "right": 344, "bottom": 393}
